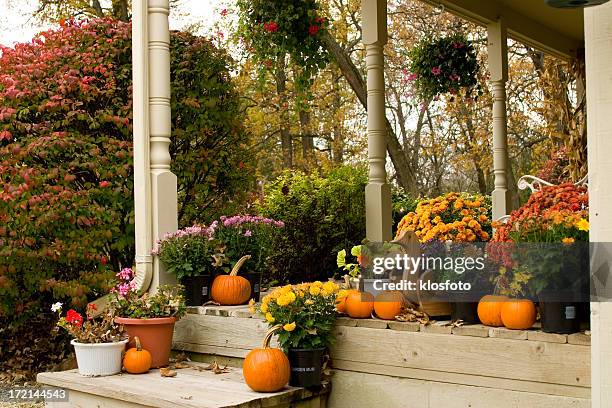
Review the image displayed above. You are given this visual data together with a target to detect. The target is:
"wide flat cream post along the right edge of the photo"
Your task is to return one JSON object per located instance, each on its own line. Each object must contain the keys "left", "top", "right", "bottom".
{"left": 584, "top": 3, "right": 612, "bottom": 408}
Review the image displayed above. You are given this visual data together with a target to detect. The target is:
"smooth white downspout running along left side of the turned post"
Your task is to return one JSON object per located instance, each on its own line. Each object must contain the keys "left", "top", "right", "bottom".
{"left": 132, "top": 0, "right": 153, "bottom": 290}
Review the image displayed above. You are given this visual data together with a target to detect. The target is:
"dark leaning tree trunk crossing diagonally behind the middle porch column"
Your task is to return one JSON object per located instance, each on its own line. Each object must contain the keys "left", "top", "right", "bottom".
{"left": 323, "top": 32, "right": 417, "bottom": 194}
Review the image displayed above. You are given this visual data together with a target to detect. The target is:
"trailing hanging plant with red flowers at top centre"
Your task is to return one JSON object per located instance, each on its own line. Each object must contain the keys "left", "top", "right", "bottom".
{"left": 238, "top": 0, "right": 328, "bottom": 99}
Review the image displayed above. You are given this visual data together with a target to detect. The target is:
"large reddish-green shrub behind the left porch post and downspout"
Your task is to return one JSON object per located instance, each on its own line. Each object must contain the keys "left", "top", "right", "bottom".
{"left": 0, "top": 20, "right": 252, "bottom": 324}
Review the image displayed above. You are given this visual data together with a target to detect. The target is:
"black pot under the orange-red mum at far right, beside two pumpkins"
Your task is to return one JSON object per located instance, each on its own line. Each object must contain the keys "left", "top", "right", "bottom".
{"left": 539, "top": 291, "right": 583, "bottom": 334}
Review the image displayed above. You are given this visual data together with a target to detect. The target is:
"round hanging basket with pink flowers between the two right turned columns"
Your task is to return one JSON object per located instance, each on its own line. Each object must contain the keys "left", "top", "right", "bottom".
{"left": 406, "top": 34, "right": 478, "bottom": 100}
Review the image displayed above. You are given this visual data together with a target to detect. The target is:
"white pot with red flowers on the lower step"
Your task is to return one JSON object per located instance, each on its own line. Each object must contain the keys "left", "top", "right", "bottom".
{"left": 51, "top": 302, "right": 128, "bottom": 377}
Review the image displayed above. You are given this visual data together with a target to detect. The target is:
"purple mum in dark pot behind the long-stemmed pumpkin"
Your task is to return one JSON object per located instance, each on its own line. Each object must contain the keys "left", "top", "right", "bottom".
{"left": 209, "top": 214, "right": 285, "bottom": 301}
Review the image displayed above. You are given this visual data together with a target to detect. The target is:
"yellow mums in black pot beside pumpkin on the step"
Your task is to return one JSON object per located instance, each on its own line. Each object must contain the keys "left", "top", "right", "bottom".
{"left": 252, "top": 281, "right": 340, "bottom": 387}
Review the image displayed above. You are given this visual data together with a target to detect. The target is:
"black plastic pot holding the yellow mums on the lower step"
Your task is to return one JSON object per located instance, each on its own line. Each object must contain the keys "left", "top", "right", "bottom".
{"left": 289, "top": 348, "right": 325, "bottom": 388}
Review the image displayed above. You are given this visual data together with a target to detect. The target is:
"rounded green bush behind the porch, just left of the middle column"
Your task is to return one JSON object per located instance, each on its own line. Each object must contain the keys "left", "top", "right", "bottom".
{"left": 259, "top": 166, "right": 367, "bottom": 282}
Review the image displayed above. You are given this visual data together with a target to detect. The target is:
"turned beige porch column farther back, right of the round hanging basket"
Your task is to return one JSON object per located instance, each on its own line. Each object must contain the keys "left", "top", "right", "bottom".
{"left": 487, "top": 19, "right": 511, "bottom": 220}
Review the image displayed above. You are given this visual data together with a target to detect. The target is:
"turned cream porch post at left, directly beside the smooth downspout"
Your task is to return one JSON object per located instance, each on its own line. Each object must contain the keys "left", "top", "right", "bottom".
{"left": 148, "top": 0, "right": 178, "bottom": 291}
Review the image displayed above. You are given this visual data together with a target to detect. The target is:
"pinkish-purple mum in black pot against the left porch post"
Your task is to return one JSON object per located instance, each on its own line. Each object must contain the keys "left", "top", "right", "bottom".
{"left": 153, "top": 223, "right": 217, "bottom": 306}
